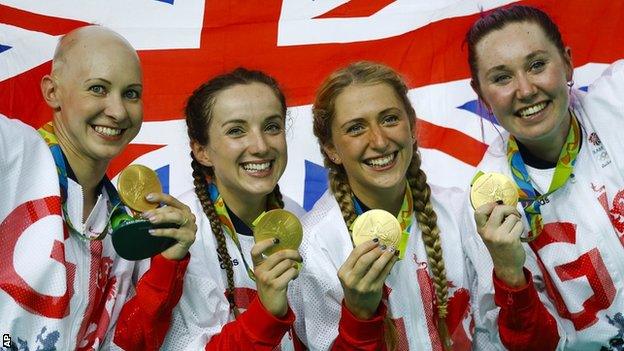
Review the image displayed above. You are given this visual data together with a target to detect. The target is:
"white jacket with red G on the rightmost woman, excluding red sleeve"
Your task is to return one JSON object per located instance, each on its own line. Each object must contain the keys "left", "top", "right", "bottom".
{"left": 464, "top": 60, "right": 624, "bottom": 350}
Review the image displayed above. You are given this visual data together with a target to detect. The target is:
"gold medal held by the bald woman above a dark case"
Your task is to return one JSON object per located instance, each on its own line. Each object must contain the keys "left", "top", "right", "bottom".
{"left": 117, "top": 164, "right": 162, "bottom": 212}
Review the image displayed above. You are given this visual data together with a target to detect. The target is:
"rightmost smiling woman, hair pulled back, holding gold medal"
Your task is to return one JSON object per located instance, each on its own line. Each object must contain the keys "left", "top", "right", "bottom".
{"left": 464, "top": 6, "right": 624, "bottom": 350}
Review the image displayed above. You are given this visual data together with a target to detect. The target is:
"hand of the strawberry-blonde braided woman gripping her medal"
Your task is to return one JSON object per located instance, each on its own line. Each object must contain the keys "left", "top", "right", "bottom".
{"left": 338, "top": 240, "right": 398, "bottom": 320}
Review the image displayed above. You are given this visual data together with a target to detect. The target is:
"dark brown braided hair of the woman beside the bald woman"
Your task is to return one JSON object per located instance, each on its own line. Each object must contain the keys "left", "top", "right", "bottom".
{"left": 184, "top": 68, "right": 286, "bottom": 316}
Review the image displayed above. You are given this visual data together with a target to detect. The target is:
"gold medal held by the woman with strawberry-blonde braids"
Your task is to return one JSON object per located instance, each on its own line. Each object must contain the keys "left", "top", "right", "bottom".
{"left": 351, "top": 209, "right": 401, "bottom": 248}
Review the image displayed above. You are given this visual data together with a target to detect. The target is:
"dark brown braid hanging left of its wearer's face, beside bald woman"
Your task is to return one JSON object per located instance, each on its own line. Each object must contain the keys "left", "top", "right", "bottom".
{"left": 191, "top": 157, "right": 238, "bottom": 316}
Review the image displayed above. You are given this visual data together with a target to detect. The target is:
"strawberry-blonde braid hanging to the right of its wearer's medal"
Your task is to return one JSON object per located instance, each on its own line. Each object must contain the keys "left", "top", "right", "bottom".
{"left": 407, "top": 143, "right": 450, "bottom": 349}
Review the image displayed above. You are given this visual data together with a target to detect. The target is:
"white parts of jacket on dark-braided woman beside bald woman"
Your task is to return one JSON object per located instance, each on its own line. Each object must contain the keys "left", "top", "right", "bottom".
{"left": 162, "top": 190, "right": 305, "bottom": 351}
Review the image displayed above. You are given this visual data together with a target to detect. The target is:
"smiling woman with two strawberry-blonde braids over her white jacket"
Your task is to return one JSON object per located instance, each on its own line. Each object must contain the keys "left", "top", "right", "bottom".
{"left": 289, "top": 62, "right": 471, "bottom": 350}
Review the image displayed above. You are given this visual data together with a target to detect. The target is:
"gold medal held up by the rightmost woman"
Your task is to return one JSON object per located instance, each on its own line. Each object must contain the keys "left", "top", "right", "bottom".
{"left": 470, "top": 173, "right": 518, "bottom": 209}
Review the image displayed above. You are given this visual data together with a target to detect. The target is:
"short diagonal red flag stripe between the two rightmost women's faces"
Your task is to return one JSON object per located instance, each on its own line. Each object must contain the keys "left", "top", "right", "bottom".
{"left": 416, "top": 119, "right": 487, "bottom": 166}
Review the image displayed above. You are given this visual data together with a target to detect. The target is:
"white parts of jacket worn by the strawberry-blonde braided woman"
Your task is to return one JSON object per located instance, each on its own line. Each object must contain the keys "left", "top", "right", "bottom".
{"left": 289, "top": 187, "right": 472, "bottom": 350}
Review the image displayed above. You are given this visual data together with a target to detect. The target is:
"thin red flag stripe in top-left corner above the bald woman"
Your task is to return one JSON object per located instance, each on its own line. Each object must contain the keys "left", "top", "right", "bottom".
{"left": 0, "top": 5, "right": 89, "bottom": 35}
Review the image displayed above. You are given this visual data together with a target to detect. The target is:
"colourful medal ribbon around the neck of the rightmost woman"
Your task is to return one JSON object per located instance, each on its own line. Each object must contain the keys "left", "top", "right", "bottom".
{"left": 507, "top": 112, "right": 581, "bottom": 241}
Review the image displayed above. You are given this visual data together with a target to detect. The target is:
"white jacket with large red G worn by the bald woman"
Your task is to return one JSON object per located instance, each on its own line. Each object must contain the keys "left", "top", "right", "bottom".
{"left": 0, "top": 116, "right": 144, "bottom": 350}
